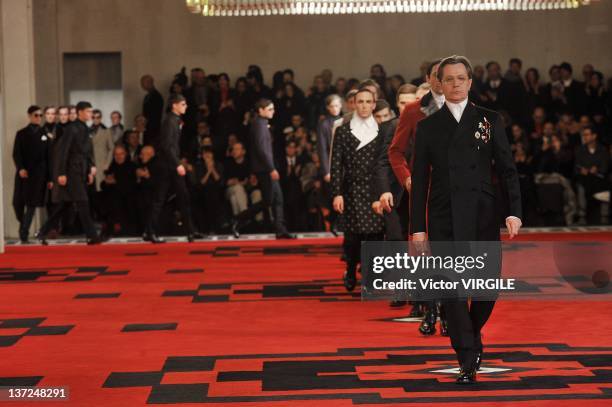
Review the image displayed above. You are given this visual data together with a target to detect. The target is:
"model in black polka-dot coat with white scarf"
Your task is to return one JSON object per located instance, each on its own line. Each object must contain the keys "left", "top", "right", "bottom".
{"left": 331, "top": 87, "right": 384, "bottom": 291}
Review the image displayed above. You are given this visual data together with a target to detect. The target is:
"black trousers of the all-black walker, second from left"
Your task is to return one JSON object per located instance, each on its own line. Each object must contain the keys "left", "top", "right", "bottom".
{"left": 145, "top": 169, "right": 195, "bottom": 234}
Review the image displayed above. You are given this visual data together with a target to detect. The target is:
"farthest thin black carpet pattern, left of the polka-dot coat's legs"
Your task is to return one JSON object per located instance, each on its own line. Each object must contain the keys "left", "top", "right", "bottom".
{"left": 189, "top": 244, "right": 342, "bottom": 257}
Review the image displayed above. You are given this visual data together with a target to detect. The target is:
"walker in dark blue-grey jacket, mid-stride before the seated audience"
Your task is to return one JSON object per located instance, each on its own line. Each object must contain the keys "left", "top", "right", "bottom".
{"left": 232, "top": 99, "right": 295, "bottom": 239}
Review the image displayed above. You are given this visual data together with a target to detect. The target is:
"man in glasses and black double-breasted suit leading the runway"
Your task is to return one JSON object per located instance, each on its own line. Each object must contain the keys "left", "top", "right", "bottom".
{"left": 410, "top": 56, "right": 521, "bottom": 384}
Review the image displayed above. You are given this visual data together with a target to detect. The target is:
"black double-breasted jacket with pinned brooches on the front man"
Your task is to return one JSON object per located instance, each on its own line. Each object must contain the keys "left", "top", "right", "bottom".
{"left": 410, "top": 103, "right": 521, "bottom": 241}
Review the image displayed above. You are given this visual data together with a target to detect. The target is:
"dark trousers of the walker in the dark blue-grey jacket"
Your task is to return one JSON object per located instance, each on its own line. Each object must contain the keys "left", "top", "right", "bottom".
{"left": 238, "top": 172, "right": 287, "bottom": 234}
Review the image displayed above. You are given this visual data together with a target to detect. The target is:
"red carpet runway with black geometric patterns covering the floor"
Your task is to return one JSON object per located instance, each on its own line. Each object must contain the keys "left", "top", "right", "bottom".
{"left": 0, "top": 233, "right": 612, "bottom": 407}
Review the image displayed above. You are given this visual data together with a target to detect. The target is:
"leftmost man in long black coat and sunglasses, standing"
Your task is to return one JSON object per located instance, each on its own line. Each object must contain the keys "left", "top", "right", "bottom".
{"left": 13, "top": 106, "right": 52, "bottom": 243}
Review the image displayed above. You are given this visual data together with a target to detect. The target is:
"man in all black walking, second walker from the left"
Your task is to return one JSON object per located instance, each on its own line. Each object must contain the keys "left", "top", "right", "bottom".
{"left": 143, "top": 95, "right": 202, "bottom": 243}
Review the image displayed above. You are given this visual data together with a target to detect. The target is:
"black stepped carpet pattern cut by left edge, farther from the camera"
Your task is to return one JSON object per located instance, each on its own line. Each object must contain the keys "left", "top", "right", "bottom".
{"left": 0, "top": 266, "right": 129, "bottom": 284}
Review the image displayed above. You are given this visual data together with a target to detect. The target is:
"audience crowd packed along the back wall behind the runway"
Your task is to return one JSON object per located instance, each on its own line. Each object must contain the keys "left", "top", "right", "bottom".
{"left": 13, "top": 58, "right": 612, "bottom": 242}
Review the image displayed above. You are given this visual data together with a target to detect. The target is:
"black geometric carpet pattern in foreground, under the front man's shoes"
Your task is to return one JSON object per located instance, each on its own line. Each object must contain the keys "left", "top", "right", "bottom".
{"left": 103, "top": 343, "right": 612, "bottom": 405}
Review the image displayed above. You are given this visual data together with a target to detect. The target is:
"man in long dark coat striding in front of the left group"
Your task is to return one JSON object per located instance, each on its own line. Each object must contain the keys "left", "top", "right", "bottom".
{"left": 37, "top": 102, "right": 102, "bottom": 244}
